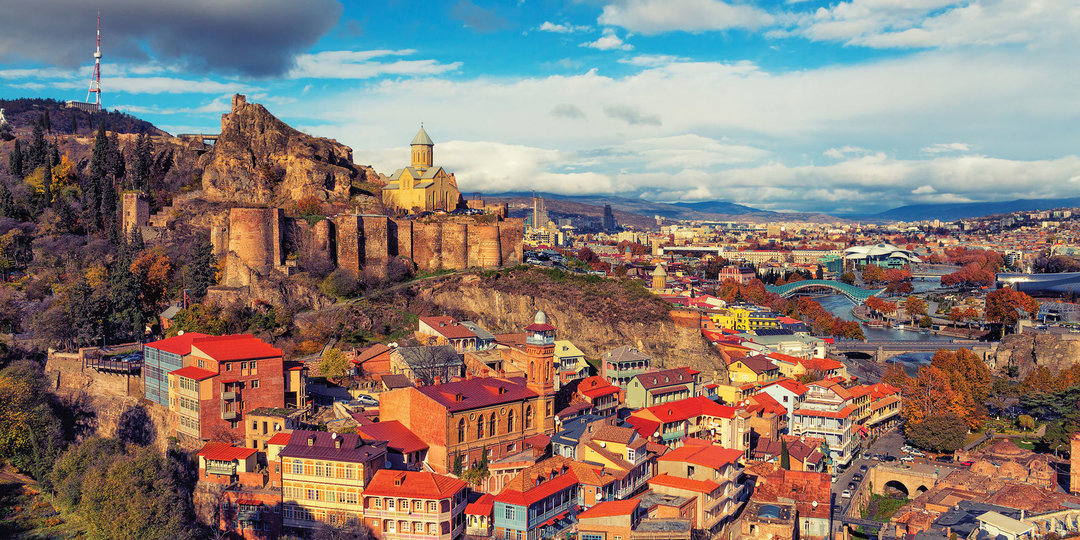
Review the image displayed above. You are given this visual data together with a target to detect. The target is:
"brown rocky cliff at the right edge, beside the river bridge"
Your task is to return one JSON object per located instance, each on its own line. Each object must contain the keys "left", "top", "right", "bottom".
{"left": 993, "top": 329, "right": 1080, "bottom": 378}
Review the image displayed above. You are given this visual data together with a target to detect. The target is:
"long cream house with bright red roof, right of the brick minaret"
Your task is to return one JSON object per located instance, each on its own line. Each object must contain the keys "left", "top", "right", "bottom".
{"left": 626, "top": 395, "right": 750, "bottom": 450}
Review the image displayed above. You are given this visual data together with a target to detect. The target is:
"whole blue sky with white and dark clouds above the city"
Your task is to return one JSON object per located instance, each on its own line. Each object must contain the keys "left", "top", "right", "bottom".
{"left": 0, "top": 0, "right": 1080, "bottom": 214}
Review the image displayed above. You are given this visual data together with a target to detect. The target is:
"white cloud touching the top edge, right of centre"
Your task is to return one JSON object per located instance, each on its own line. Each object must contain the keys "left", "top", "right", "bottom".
{"left": 597, "top": 0, "right": 773, "bottom": 36}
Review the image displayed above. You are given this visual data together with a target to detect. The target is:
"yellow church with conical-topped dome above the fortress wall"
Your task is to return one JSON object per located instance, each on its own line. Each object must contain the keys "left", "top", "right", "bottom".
{"left": 382, "top": 126, "right": 461, "bottom": 212}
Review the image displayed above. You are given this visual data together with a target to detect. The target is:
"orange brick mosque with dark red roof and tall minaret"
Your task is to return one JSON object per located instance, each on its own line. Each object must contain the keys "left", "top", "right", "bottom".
{"left": 379, "top": 312, "right": 555, "bottom": 474}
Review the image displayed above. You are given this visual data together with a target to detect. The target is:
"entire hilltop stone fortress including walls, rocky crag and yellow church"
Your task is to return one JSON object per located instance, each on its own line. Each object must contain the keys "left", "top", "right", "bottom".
{"left": 122, "top": 95, "right": 524, "bottom": 299}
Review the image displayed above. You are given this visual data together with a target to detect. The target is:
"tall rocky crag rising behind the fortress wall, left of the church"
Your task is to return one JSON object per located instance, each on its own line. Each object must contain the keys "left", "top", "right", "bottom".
{"left": 202, "top": 95, "right": 369, "bottom": 205}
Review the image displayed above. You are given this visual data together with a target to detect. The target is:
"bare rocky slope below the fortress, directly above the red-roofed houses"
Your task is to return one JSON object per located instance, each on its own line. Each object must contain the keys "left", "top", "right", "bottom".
{"left": 406, "top": 273, "right": 725, "bottom": 377}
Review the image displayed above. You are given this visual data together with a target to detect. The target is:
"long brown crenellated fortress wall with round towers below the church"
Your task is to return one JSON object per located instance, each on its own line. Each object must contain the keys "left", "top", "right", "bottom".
{"left": 217, "top": 208, "right": 524, "bottom": 287}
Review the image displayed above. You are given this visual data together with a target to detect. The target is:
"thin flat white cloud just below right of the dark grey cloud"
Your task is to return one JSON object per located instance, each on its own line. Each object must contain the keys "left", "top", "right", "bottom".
{"left": 288, "top": 49, "right": 461, "bottom": 79}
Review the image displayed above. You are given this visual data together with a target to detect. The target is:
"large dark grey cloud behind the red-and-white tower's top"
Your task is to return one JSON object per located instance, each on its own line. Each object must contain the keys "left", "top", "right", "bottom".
{"left": 0, "top": 0, "right": 342, "bottom": 77}
